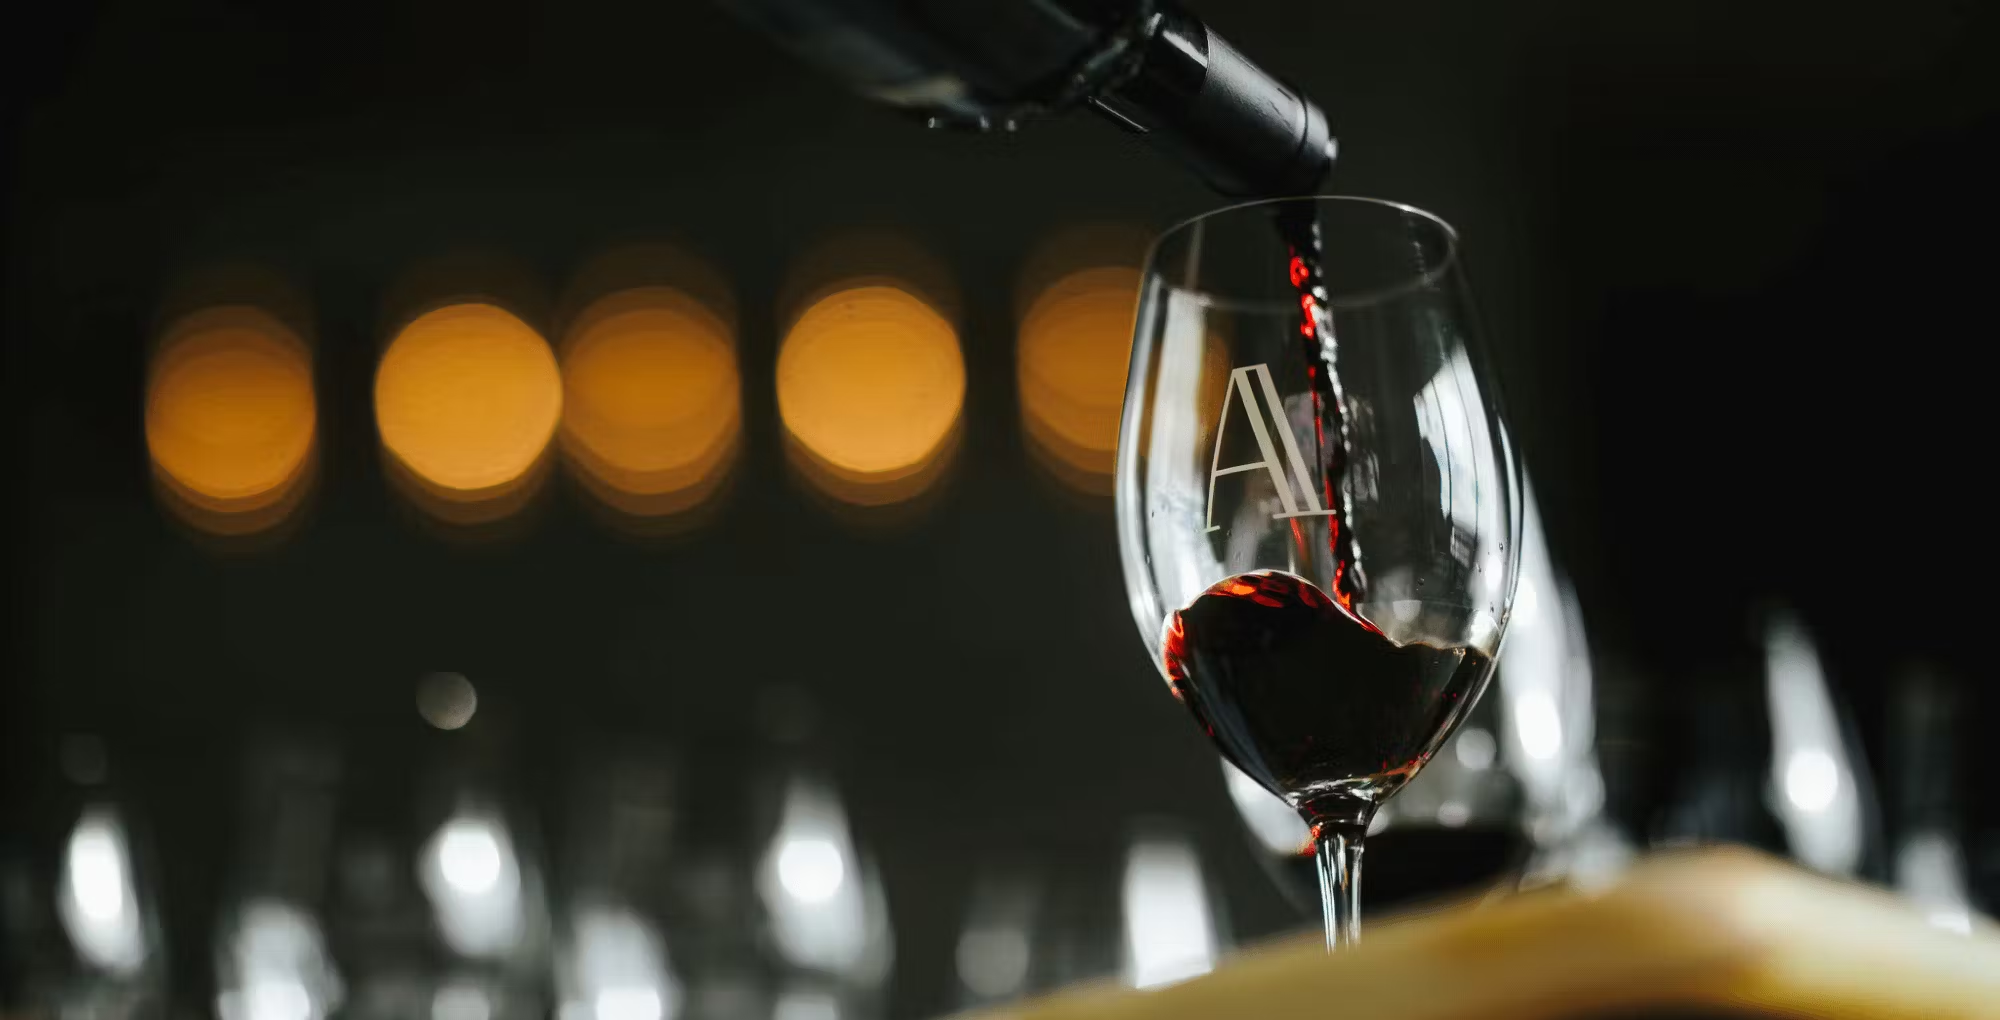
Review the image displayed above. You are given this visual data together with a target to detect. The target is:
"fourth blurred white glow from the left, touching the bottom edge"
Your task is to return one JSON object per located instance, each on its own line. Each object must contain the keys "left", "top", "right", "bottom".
{"left": 556, "top": 906, "right": 682, "bottom": 1020}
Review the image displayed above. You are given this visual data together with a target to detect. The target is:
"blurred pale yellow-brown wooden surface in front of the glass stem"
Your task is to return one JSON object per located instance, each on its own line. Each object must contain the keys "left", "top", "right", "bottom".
{"left": 980, "top": 850, "right": 2000, "bottom": 1020}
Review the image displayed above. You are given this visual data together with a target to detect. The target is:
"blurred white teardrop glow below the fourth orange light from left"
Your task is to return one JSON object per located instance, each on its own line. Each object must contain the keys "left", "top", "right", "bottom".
{"left": 756, "top": 778, "right": 892, "bottom": 984}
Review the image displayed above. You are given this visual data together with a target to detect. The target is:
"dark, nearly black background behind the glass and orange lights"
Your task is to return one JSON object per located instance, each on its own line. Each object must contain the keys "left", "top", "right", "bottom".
{"left": 0, "top": 0, "right": 2000, "bottom": 1016}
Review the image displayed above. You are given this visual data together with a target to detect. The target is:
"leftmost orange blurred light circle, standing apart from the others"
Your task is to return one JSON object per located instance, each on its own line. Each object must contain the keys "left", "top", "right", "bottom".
{"left": 146, "top": 304, "right": 318, "bottom": 536}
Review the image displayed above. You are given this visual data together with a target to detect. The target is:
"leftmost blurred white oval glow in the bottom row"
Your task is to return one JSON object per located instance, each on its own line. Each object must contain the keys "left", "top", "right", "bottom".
{"left": 58, "top": 808, "right": 146, "bottom": 974}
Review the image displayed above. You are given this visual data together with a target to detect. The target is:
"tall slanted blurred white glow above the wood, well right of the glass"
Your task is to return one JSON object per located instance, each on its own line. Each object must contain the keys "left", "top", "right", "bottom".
{"left": 1764, "top": 614, "right": 1868, "bottom": 874}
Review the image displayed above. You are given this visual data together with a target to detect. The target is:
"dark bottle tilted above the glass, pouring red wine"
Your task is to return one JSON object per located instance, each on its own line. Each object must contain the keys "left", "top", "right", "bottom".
{"left": 722, "top": 0, "right": 1334, "bottom": 196}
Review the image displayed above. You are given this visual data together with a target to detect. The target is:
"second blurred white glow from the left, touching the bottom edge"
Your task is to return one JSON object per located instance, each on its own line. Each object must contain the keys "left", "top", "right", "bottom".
{"left": 216, "top": 900, "right": 346, "bottom": 1020}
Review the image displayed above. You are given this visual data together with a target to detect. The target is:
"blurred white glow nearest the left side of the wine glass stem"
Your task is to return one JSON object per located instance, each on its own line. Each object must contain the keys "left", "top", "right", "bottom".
{"left": 1124, "top": 840, "right": 1216, "bottom": 988}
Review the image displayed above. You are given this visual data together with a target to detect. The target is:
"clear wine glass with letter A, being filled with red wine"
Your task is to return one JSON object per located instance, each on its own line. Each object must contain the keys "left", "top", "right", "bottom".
{"left": 1116, "top": 198, "right": 1520, "bottom": 948}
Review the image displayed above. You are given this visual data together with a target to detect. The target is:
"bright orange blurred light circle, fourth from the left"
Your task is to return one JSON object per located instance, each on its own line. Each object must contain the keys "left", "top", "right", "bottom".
{"left": 778, "top": 284, "right": 966, "bottom": 506}
